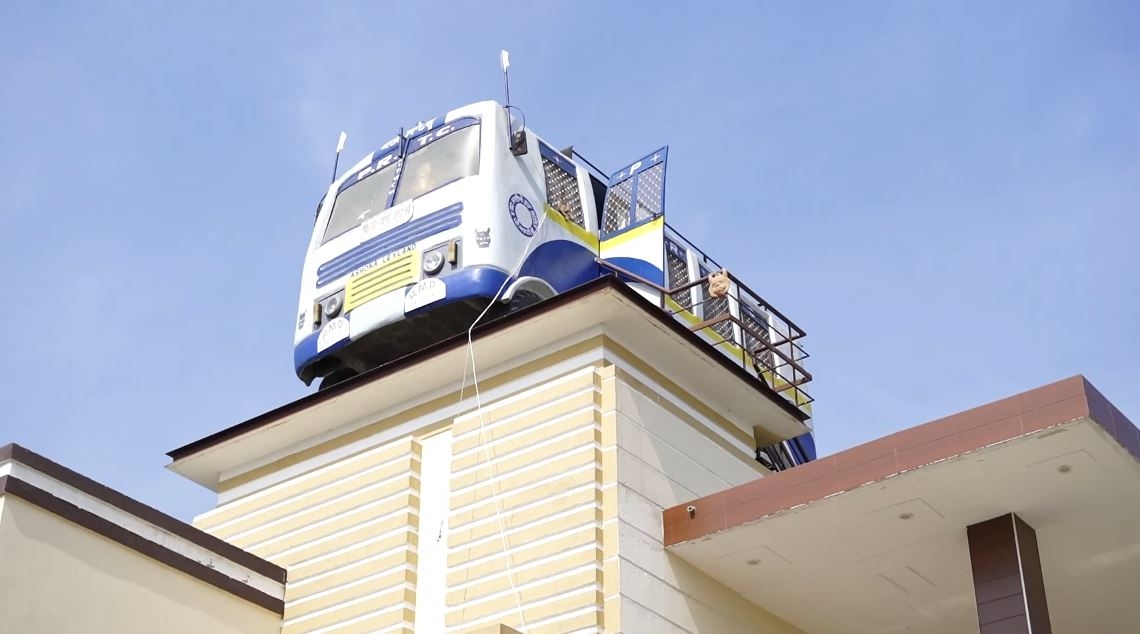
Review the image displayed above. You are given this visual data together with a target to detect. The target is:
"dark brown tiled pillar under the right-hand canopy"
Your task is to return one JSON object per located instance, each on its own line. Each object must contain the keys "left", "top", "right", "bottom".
{"left": 966, "top": 513, "right": 1051, "bottom": 634}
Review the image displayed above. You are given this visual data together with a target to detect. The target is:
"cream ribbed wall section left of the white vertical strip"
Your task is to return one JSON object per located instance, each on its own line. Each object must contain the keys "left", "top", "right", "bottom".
{"left": 195, "top": 438, "right": 420, "bottom": 634}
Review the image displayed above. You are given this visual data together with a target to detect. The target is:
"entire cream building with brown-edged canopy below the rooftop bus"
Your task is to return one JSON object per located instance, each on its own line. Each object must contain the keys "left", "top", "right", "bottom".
{"left": 0, "top": 278, "right": 1140, "bottom": 634}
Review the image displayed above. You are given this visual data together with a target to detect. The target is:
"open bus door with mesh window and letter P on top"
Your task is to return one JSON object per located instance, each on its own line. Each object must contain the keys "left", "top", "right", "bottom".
{"left": 599, "top": 146, "right": 669, "bottom": 306}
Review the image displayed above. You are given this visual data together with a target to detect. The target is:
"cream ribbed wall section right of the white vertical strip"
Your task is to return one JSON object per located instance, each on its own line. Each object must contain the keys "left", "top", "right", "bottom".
{"left": 446, "top": 367, "right": 603, "bottom": 634}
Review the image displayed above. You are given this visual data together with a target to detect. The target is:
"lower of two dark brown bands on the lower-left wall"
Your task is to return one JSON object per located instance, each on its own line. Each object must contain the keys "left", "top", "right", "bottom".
{"left": 0, "top": 474, "right": 285, "bottom": 616}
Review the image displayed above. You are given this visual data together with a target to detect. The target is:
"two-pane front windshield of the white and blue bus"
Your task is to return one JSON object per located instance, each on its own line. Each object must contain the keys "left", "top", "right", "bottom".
{"left": 321, "top": 125, "right": 479, "bottom": 242}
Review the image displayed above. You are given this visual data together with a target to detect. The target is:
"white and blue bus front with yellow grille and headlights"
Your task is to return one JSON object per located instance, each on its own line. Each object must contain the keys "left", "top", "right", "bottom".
{"left": 294, "top": 101, "right": 538, "bottom": 384}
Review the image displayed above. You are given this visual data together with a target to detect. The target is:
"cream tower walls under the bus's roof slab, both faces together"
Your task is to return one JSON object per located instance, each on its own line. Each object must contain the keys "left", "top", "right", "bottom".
{"left": 196, "top": 338, "right": 796, "bottom": 634}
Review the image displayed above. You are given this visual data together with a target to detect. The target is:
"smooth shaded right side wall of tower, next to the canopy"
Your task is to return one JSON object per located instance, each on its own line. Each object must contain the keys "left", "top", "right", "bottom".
{"left": 614, "top": 371, "right": 800, "bottom": 634}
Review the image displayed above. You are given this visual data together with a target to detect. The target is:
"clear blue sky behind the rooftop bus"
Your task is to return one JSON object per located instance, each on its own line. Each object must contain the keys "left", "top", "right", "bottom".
{"left": 0, "top": 0, "right": 1140, "bottom": 519}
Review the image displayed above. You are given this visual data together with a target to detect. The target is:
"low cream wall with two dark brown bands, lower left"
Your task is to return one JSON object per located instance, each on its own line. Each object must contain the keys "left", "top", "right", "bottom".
{"left": 0, "top": 445, "right": 285, "bottom": 634}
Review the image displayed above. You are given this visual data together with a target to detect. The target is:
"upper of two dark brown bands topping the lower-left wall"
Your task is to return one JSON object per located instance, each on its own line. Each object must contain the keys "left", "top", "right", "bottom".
{"left": 0, "top": 445, "right": 285, "bottom": 583}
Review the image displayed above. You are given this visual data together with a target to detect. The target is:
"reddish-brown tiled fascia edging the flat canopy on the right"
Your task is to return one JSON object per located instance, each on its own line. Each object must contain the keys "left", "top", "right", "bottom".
{"left": 663, "top": 376, "right": 1140, "bottom": 546}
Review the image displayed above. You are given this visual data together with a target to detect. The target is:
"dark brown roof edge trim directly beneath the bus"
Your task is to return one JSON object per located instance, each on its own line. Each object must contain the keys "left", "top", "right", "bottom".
{"left": 166, "top": 275, "right": 808, "bottom": 461}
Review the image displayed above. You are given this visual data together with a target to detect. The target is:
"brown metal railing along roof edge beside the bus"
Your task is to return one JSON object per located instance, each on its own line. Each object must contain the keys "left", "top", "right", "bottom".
{"left": 596, "top": 245, "right": 813, "bottom": 415}
